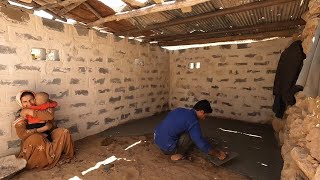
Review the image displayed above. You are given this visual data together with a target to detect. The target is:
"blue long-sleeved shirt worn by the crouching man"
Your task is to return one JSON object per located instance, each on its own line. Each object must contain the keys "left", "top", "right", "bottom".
{"left": 154, "top": 108, "right": 212, "bottom": 153}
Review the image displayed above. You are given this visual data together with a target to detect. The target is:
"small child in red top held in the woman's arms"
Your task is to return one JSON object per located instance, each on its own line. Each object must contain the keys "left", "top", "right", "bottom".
{"left": 27, "top": 92, "right": 58, "bottom": 142}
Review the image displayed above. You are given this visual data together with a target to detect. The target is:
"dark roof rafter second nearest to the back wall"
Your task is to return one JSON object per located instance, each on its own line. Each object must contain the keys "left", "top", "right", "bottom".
{"left": 145, "top": 19, "right": 306, "bottom": 42}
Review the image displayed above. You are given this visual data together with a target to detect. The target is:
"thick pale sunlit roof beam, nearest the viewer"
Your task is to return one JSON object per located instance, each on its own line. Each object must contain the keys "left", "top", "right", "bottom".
{"left": 88, "top": 0, "right": 209, "bottom": 26}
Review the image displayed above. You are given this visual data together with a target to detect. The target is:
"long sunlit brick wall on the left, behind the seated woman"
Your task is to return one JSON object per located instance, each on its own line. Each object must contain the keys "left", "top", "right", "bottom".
{"left": 0, "top": 8, "right": 169, "bottom": 157}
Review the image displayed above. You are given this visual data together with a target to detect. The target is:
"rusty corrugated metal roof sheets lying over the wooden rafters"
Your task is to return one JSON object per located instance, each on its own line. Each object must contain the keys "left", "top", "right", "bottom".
{"left": 6, "top": 0, "right": 309, "bottom": 44}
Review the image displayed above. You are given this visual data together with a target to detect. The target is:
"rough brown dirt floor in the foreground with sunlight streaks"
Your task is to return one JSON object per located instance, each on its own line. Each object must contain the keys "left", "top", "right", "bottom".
{"left": 13, "top": 135, "right": 248, "bottom": 180}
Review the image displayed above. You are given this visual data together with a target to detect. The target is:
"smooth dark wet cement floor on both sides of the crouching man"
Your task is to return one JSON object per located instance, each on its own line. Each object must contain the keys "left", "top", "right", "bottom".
{"left": 100, "top": 112, "right": 283, "bottom": 180}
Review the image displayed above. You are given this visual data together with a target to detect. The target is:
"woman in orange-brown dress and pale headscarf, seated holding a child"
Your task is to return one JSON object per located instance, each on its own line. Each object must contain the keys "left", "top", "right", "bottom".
{"left": 14, "top": 91, "right": 74, "bottom": 169}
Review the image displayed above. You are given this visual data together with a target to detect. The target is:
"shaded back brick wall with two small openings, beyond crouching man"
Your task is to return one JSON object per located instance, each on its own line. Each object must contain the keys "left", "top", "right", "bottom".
{"left": 170, "top": 38, "right": 290, "bottom": 123}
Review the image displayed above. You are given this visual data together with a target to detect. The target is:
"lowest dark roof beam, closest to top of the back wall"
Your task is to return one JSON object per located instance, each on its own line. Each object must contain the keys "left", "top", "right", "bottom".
{"left": 158, "top": 30, "right": 295, "bottom": 46}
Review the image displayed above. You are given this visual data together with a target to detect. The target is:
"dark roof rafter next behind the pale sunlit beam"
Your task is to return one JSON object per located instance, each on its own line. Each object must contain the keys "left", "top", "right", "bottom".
{"left": 121, "top": 0, "right": 296, "bottom": 35}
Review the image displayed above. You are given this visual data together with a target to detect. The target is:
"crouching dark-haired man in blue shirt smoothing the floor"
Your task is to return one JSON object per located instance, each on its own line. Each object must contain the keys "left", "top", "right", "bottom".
{"left": 154, "top": 100, "right": 226, "bottom": 161}
